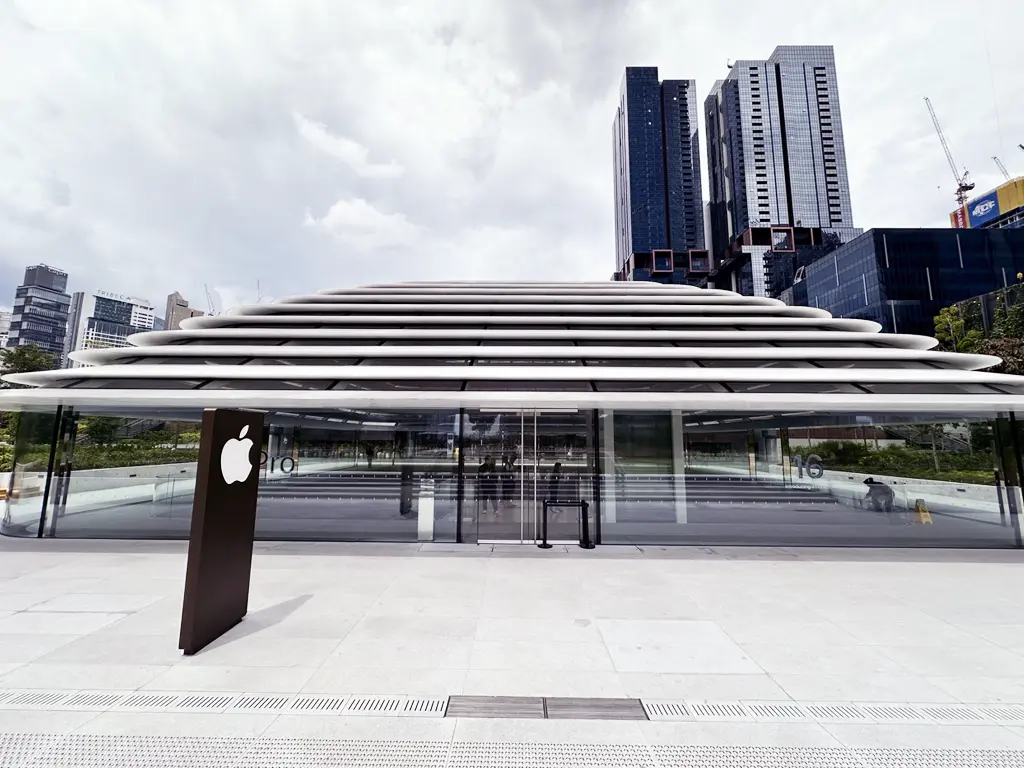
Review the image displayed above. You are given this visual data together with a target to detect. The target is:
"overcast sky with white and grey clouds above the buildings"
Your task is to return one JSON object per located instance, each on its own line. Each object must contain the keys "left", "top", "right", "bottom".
{"left": 0, "top": 0, "right": 1024, "bottom": 311}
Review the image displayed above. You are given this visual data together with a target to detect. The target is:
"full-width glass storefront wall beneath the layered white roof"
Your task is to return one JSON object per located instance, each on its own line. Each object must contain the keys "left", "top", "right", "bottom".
{"left": 2, "top": 408, "right": 1024, "bottom": 547}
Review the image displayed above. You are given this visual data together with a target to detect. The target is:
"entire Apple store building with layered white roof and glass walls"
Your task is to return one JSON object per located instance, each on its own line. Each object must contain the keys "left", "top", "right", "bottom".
{"left": 6, "top": 282, "right": 1024, "bottom": 547}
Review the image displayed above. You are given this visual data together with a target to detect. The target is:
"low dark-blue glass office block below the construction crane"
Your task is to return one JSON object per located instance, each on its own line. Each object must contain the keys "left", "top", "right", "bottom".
{"left": 783, "top": 229, "right": 1024, "bottom": 336}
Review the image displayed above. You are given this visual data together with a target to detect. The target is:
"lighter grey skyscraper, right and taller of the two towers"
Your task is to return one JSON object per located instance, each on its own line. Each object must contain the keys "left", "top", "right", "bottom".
{"left": 705, "top": 45, "right": 853, "bottom": 265}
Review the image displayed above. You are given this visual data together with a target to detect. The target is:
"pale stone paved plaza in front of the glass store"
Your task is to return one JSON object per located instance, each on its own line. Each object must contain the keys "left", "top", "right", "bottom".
{"left": 0, "top": 539, "right": 1024, "bottom": 766}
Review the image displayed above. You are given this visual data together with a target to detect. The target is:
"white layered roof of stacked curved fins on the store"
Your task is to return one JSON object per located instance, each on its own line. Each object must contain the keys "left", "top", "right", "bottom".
{"left": 0, "top": 283, "right": 1024, "bottom": 412}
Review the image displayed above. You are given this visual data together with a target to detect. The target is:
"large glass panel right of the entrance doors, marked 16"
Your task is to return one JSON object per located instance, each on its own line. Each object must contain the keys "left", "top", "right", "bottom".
{"left": 600, "top": 412, "right": 1020, "bottom": 547}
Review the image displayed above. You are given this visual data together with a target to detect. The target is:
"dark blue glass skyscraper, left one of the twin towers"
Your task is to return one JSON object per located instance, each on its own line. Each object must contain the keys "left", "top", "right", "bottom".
{"left": 613, "top": 67, "right": 707, "bottom": 283}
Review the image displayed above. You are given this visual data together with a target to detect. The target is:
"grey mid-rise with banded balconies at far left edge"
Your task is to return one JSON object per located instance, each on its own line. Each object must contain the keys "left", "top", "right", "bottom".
{"left": 7, "top": 264, "right": 71, "bottom": 367}
